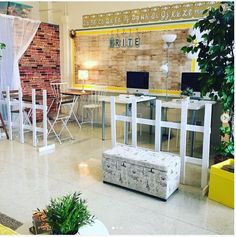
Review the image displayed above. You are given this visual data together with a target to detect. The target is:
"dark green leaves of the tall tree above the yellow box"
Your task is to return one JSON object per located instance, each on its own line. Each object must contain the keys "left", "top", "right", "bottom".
{"left": 181, "top": 1, "right": 234, "bottom": 159}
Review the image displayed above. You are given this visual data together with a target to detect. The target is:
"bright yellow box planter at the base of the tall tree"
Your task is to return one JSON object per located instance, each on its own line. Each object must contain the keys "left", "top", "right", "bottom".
{"left": 208, "top": 159, "right": 234, "bottom": 208}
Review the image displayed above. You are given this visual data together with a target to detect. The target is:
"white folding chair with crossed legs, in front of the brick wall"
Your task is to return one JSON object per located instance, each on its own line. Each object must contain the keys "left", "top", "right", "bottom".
{"left": 48, "top": 83, "right": 77, "bottom": 144}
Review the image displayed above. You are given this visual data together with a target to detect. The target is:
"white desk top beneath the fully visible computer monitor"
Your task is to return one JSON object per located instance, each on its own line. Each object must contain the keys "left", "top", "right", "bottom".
{"left": 98, "top": 94, "right": 156, "bottom": 104}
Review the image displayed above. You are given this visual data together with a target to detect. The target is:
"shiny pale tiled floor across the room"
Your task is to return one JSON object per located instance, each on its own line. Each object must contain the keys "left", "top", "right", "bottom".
{"left": 0, "top": 125, "right": 234, "bottom": 235}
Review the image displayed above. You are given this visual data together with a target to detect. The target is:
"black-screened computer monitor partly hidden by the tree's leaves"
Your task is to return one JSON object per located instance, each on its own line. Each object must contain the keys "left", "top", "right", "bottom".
{"left": 181, "top": 72, "right": 205, "bottom": 97}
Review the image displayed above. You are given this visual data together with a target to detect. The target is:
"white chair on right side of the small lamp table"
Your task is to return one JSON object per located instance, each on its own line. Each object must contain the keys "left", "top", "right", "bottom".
{"left": 82, "top": 88, "right": 105, "bottom": 125}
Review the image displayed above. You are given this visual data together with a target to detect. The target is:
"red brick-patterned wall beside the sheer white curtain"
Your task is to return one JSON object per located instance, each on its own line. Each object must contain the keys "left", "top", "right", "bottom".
{"left": 19, "top": 23, "right": 61, "bottom": 94}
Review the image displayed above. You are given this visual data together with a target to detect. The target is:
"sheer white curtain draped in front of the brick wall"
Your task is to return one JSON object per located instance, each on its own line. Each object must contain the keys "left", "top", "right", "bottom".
{"left": 0, "top": 14, "right": 40, "bottom": 91}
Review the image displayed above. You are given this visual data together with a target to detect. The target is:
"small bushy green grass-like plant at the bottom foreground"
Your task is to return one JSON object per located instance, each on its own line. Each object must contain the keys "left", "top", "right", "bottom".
{"left": 46, "top": 192, "right": 94, "bottom": 235}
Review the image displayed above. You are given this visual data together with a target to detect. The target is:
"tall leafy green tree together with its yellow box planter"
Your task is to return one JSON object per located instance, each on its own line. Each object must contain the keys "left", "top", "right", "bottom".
{"left": 182, "top": 1, "right": 234, "bottom": 208}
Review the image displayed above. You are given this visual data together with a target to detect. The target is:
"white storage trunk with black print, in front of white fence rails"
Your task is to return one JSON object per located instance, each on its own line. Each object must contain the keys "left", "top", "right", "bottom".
{"left": 102, "top": 144, "right": 180, "bottom": 200}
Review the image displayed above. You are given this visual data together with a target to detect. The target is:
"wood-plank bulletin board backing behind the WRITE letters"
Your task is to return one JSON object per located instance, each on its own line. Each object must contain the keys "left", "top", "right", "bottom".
{"left": 75, "top": 29, "right": 191, "bottom": 90}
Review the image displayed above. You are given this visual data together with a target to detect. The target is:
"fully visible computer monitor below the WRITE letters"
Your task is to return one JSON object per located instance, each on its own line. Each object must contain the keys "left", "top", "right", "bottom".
{"left": 126, "top": 71, "right": 149, "bottom": 94}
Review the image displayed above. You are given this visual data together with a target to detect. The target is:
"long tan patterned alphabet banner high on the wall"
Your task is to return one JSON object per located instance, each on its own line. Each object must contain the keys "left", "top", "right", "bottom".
{"left": 83, "top": 1, "right": 220, "bottom": 28}
